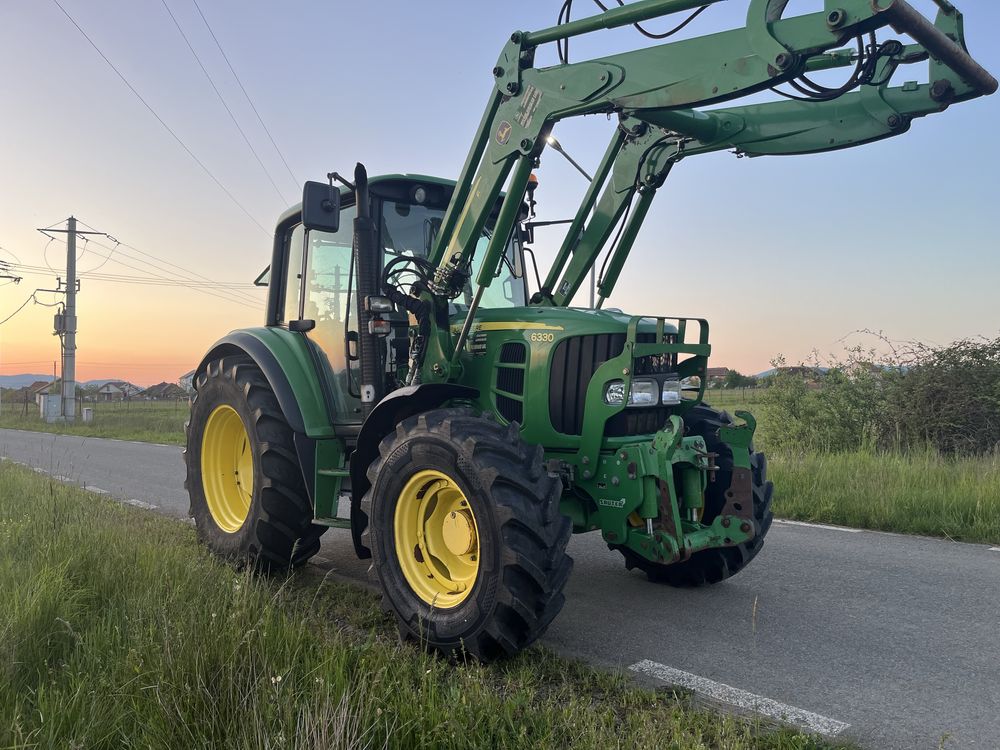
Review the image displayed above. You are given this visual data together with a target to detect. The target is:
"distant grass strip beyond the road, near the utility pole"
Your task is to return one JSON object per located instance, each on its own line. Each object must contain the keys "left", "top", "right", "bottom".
{"left": 0, "top": 401, "right": 188, "bottom": 445}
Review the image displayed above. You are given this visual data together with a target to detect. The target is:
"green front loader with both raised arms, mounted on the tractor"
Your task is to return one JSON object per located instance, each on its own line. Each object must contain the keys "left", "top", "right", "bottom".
{"left": 416, "top": 0, "right": 997, "bottom": 379}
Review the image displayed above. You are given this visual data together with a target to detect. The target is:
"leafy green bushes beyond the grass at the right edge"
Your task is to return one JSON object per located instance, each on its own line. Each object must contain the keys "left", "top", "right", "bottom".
{"left": 763, "top": 337, "right": 1000, "bottom": 456}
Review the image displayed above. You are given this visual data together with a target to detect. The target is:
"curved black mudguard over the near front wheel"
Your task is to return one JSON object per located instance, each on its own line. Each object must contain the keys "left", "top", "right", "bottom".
{"left": 351, "top": 383, "right": 479, "bottom": 560}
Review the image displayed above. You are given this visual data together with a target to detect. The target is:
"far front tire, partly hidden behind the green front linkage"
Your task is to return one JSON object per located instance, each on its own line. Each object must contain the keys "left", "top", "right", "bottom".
{"left": 618, "top": 404, "right": 774, "bottom": 588}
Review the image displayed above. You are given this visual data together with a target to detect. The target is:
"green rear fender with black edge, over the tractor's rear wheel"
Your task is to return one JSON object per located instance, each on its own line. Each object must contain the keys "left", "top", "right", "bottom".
{"left": 194, "top": 327, "right": 335, "bottom": 439}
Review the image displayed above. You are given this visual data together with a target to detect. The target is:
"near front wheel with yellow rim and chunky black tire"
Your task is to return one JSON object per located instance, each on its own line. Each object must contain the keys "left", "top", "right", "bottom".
{"left": 362, "top": 409, "right": 573, "bottom": 661}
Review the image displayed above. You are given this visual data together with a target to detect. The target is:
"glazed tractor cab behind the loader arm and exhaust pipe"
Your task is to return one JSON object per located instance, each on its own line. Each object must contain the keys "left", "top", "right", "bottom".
{"left": 266, "top": 175, "right": 528, "bottom": 424}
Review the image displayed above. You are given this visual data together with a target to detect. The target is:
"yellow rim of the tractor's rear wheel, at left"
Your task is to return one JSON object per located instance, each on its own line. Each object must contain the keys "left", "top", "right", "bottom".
{"left": 201, "top": 405, "right": 253, "bottom": 534}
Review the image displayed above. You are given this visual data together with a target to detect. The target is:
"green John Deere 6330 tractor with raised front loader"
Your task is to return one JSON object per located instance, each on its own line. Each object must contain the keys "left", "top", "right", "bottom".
{"left": 186, "top": 0, "right": 997, "bottom": 660}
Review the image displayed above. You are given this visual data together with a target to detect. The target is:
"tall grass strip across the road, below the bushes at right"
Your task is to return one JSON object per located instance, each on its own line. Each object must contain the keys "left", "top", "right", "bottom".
{"left": 768, "top": 451, "right": 1000, "bottom": 544}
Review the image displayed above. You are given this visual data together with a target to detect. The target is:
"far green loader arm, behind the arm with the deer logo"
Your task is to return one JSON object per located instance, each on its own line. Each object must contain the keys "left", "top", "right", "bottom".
{"left": 535, "top": 5, "right": 996, "bottom": 306}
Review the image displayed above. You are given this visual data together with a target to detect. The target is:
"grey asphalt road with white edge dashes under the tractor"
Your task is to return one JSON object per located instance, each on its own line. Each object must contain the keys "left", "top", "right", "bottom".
{"left": 0, "top": 430, "right": 1000, "bottom": 750}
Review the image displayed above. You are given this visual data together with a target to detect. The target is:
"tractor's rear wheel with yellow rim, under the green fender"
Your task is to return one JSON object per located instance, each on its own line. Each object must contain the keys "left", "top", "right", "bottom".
{"left": 184, "top": 355, "right": 326, "bottom": 572}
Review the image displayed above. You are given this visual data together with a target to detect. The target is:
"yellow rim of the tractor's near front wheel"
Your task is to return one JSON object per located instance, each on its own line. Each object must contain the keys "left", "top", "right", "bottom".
{"left": 393, "top": 469, "right": 479, "bottom": 609}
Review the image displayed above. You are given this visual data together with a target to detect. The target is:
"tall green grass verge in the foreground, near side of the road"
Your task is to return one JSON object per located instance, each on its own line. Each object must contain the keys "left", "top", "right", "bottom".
{"left": 0, "top": 463, "right": 848, "bottom": 750}
